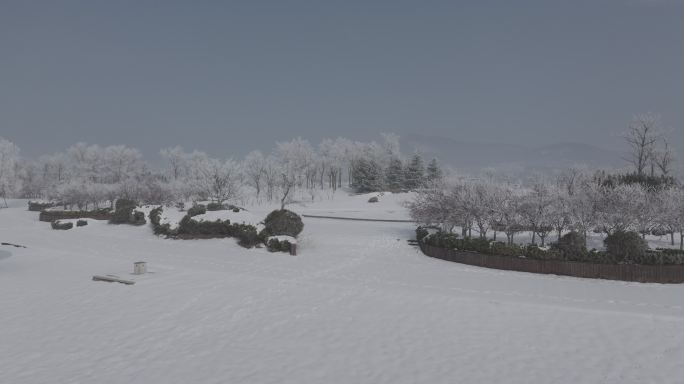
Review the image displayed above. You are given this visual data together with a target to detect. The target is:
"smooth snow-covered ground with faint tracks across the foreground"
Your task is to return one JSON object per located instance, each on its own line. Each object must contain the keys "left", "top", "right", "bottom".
{"left": 0, "top": 194, "right": 684, "bottom": 384}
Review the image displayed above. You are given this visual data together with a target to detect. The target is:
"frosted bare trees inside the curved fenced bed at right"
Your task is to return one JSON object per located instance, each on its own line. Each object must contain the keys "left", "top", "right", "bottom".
{"left": 409, "top": 170, "right": 684, "bottom": 248}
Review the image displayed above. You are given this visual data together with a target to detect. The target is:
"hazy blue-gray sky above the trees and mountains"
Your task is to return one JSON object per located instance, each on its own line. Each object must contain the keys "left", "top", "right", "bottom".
{"left": 0, "top": 0, "right": 684, "bottom": 156}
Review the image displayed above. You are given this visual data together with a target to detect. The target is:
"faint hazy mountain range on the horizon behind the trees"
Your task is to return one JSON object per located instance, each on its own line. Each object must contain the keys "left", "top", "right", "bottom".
{"left": 401, "top": 134, "right": 626, "bottom": 173}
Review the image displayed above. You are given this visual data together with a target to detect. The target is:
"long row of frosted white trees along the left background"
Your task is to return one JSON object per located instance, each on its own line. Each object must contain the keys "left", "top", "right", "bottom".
{"left": 0, "top": 134, "right": 441, "bottom": 210}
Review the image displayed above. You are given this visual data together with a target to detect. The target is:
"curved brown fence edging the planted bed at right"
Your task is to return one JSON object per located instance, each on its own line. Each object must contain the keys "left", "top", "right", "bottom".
{"left": 420, "top": 244, "right": 684, "bottom": 284}
